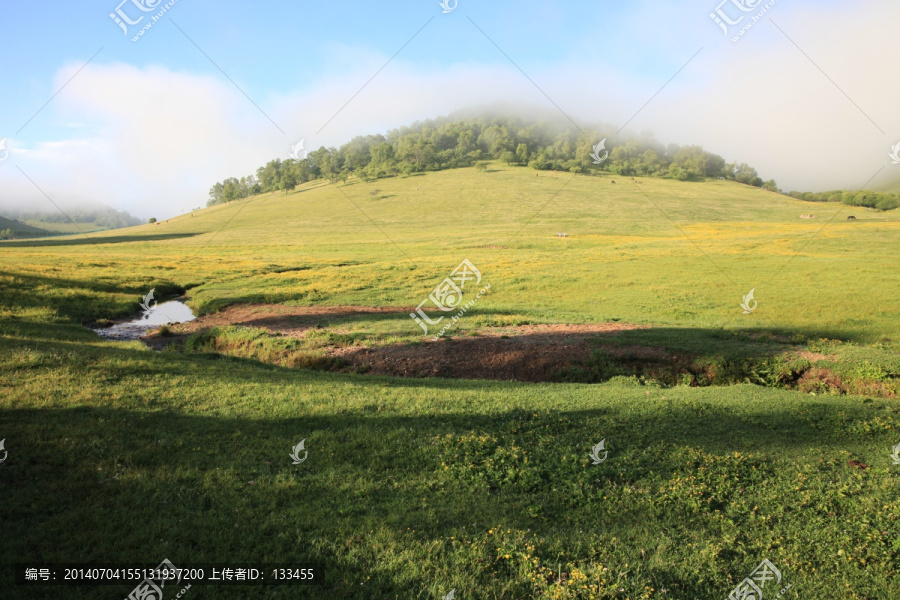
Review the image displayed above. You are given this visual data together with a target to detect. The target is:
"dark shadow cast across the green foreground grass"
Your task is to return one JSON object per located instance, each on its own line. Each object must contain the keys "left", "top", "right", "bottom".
{"left": 0, "top": 386, "right": 888, "bottom": 599}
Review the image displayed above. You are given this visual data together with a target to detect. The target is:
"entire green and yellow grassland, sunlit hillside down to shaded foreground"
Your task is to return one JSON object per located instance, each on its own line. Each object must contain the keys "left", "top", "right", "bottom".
{"left": 0, "top": 165, "right": 900, "bottom": 600}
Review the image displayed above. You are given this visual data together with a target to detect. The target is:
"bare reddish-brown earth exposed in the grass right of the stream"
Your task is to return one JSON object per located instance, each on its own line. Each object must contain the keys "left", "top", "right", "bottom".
{"left": 142, "top": 304, "right": 897, "bottom": 397}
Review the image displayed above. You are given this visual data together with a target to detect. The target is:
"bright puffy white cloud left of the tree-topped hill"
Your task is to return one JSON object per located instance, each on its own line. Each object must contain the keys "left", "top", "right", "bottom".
{"left": 0, "top": 64, "right": 280, "bottom": 217}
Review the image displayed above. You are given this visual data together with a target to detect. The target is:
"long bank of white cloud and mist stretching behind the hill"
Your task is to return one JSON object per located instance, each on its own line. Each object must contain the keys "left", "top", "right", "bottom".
{"left": 0, "top": 0, "right": 900, "bottom": 218}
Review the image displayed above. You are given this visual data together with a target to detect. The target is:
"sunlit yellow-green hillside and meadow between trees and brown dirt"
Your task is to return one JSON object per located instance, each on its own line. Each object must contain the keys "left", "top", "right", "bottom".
{"left": 4, "top": 166, "right": 900, "bottom": 341}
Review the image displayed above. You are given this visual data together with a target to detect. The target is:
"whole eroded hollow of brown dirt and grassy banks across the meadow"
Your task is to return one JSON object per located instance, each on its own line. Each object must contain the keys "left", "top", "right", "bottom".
{"left": 142, "top": 304, "right": 900, "bottom": 397}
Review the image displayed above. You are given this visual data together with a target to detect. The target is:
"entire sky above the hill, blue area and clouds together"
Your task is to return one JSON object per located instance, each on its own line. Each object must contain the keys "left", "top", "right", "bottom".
{"left": 0, "top": 0, "right": 900, "bottom": 216}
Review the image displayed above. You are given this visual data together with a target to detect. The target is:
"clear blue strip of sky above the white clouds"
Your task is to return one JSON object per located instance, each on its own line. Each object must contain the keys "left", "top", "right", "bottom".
{"left": 0, "top": 0, "right": 684, "bottom": 136}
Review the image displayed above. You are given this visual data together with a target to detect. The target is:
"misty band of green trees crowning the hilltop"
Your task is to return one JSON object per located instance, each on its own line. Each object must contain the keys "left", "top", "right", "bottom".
{"left": 207, "top": 117, "right": 777, "bottom": 206}
